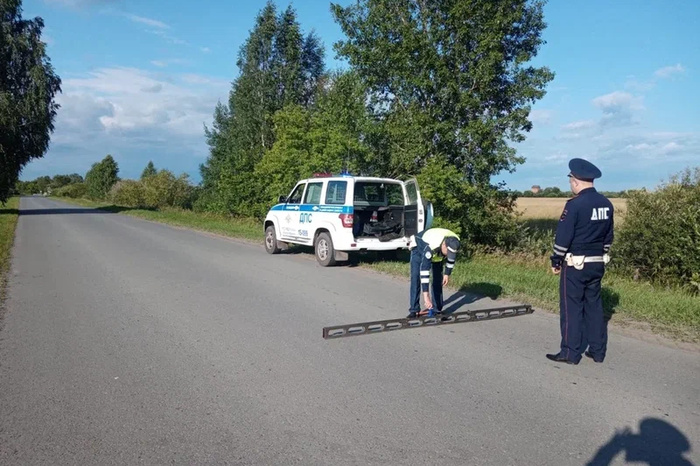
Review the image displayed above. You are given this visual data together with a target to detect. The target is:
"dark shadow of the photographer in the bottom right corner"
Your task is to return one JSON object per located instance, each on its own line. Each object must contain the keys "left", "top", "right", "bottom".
{"left": 586, "top": 418, "right": 693, "bottom": 466}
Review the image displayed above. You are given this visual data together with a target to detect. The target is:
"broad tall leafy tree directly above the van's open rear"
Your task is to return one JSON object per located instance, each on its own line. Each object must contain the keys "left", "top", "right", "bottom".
{"left": 332, "top": 0, "right": 554, "bottom": 185}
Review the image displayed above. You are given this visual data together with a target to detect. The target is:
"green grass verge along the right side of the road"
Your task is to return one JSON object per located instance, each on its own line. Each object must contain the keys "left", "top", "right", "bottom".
{"left": 50, "top": 198, "right": 700, "bottom": 343}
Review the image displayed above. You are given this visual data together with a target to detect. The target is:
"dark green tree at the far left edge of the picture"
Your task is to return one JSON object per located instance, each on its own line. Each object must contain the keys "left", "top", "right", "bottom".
{"left": 0, "top": 0, "right": 61, "bottom": 204}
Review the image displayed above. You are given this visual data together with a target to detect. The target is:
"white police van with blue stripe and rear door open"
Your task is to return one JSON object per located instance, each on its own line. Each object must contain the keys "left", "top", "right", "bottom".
{"left": 263, "top": 173, "right": 433, "bottom": 267}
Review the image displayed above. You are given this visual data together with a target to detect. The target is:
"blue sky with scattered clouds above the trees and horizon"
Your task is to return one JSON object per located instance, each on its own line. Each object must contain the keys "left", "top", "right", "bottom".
{"left": 21, "top": 0, "right": 700, "bottom": 190}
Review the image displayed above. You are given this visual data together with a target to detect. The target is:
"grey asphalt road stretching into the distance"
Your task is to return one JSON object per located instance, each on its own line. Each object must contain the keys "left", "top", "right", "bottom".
{"left": 0, "top": 198, "right": 700, "bottom": 466}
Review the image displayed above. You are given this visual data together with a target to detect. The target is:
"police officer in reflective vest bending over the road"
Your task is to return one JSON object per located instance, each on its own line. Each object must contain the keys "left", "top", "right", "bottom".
{"left": 408, "top": 228, "right": 460, "bottom": 319}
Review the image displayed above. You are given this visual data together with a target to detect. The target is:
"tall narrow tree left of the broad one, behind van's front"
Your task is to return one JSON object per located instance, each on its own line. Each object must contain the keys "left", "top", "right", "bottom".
{"left": 200, "top": 1, "right": 323, "bottom": 213}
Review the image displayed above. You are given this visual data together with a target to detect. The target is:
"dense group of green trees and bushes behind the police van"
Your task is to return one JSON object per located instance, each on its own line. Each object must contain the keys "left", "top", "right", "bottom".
{"left": 196, "top": 0, "right": 554, "bottom": 245}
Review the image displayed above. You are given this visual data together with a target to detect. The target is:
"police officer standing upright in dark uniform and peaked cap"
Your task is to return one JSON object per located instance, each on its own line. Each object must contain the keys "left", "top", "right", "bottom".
{"left": 547, "top": 159, "right": 613, "bottom": 364}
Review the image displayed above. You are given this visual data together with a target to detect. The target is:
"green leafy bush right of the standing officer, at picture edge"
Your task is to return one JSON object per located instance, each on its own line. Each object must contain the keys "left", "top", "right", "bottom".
{"left": 613, "top": 167, "right": 700, "bottom": 292}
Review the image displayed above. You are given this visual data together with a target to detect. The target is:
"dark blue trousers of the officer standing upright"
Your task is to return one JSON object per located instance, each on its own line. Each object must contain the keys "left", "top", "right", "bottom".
{"left": 559, "top": 262, "right": 607, "bottom": 362}
